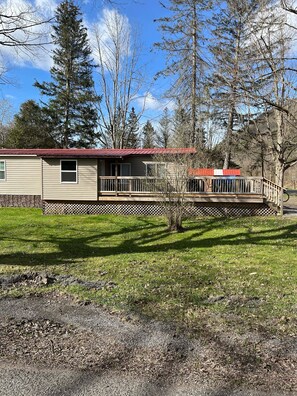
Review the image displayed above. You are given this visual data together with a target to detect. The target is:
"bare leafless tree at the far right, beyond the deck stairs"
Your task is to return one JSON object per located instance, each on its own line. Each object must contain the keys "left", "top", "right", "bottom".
{"left": 244, "top": 7, "right": 297, "bottom": 186}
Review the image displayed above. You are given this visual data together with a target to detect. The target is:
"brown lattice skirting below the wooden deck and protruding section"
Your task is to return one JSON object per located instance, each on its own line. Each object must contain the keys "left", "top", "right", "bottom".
{"left": 43, "top": 201, "right": 276, "bottom": 217}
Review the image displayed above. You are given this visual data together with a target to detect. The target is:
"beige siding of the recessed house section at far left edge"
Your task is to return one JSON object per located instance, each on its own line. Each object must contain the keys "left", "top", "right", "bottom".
{"left": 0, "top": 156, "right": 41, "bottom": 195}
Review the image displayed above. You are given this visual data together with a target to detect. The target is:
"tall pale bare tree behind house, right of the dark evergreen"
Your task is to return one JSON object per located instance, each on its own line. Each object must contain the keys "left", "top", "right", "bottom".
{"left": 94, "top": 10, "right": 143, "bottom": 148}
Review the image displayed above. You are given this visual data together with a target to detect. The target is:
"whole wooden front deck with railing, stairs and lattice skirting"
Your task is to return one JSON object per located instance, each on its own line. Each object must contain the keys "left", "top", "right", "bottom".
{"left": 43, "top": 176, "right": 282, "bottom": 217}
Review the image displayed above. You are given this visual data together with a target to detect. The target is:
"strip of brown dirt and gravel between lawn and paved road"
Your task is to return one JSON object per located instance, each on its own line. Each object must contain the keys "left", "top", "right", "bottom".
{"left": 0, "top": 294, "right": 297, "bottom": 395}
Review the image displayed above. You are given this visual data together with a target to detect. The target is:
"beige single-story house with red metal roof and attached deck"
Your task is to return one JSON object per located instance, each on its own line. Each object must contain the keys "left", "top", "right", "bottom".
{"left": 0, "top": 148, "right": 275, "bottom": 215}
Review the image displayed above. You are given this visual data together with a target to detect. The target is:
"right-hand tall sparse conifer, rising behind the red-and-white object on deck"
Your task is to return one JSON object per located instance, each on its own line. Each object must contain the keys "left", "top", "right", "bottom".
{"left": 211, "top": 0, "right": 259, "bottom": 168}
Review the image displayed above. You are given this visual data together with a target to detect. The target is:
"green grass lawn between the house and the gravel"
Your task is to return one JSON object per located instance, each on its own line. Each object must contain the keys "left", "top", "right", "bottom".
{"left": 0, "top": 208, "right": 297, "bottom": 335}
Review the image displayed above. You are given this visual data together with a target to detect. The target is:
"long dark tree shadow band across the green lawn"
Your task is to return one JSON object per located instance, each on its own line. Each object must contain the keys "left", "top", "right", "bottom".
{"left": 0, "top": 218, "right": 297, "bottom": 266}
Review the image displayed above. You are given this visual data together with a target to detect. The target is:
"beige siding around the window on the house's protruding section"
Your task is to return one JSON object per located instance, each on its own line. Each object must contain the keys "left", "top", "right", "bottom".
{"left": 43, "top": 158, "right": 98, "bottom": 201}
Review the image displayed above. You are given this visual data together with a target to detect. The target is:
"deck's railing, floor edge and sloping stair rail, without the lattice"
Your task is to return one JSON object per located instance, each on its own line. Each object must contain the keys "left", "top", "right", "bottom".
{"left": 98, "top": 176, "right": 281, "bottom": 208}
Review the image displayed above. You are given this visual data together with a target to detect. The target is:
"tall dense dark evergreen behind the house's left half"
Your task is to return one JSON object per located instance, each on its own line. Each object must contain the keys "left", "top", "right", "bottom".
{"left": 35, "top": 0, "right": 98, "bottom": 148}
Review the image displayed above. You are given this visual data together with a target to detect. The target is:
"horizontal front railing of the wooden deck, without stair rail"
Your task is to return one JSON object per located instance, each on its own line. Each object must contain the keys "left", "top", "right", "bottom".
{"left": 99, "top": 176, "right": 263, "bottom": 195}
